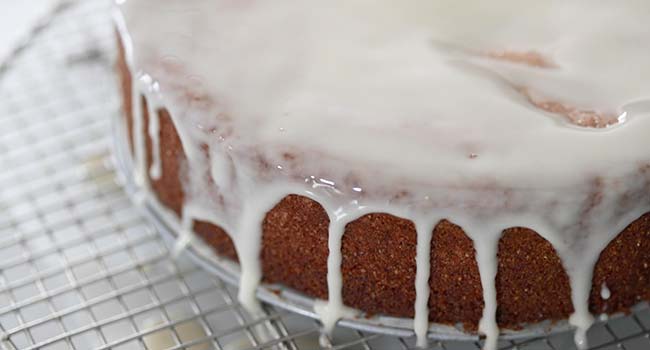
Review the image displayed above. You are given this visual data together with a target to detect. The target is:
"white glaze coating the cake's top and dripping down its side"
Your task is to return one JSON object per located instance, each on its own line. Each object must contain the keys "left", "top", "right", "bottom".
{"left": 116, "top": 0, "right": 650, "bottom": 349}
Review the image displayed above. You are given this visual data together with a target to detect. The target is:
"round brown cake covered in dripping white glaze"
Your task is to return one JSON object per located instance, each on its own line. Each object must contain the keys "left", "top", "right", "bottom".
{"left": 114, "top": 0, "right": 650, "bottom": 348}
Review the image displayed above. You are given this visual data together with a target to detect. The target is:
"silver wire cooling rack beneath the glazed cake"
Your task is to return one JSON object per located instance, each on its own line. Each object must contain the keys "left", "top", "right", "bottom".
{"left": 0, "top": 0, "right": 650, "bottom": 350}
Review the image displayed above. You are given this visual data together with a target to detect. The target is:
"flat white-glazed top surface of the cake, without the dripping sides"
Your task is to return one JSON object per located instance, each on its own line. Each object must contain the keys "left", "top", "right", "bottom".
{"left": 118, "top": 0, "right": 650, "bottom": 188}
